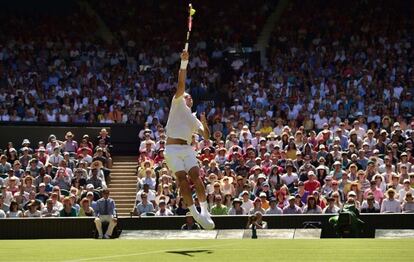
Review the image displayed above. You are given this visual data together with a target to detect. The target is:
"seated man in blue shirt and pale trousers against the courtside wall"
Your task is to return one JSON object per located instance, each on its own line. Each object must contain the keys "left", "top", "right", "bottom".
{"left": 95, "top": 189, "right": 117, "bottom": 239}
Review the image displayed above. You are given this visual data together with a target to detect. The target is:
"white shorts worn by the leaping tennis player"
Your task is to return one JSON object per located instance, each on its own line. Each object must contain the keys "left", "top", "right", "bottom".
{"left": 164, "top": 145, "right": 198, "bottom": 173}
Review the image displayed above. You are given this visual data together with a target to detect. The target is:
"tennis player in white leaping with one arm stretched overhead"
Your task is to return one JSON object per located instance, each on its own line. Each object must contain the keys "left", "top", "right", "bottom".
{"left": 164, "top": 50, "right": 215, "bottom": 229}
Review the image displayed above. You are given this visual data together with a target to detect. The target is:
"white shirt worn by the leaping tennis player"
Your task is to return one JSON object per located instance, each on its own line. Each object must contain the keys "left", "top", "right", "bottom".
{"left": 165, "top": 95, "right": 204, "bottom": 144}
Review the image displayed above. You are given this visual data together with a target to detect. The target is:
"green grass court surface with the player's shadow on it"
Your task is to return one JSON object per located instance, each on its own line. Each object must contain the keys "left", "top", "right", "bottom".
{"left": 0, "top": 239, "right": 414, "bottom": 262}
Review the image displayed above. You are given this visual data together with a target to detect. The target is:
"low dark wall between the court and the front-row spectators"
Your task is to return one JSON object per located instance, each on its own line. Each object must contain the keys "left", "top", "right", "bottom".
{"left": 0, "top": 214, "right": 414, "bottom": 239}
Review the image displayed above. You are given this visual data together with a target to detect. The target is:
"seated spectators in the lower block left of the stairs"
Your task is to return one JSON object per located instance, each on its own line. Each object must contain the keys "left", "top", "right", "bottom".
{"left": 0, "top": 129, "right": 112, "bottom": 218}
